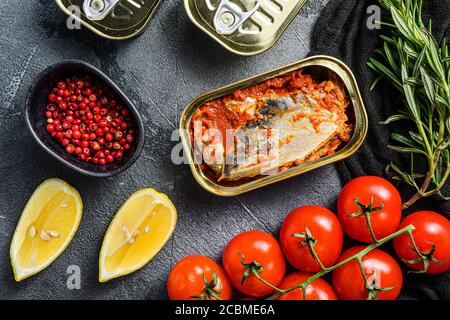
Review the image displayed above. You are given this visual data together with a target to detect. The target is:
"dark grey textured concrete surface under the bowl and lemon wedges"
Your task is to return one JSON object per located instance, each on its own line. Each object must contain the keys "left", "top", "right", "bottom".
{"left": 0, "top": 0, "right": 332, "bottom": 299}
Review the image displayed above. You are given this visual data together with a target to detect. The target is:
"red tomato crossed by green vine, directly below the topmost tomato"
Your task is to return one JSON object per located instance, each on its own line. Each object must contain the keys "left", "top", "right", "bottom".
{"left": 332, "top": 246, "right": 403, "bottom": 300}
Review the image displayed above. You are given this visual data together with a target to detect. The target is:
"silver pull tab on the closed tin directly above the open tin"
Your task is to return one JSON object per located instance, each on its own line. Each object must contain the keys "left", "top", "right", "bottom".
{"left": 214, "top": 0, "right": 262, "bottom": 35}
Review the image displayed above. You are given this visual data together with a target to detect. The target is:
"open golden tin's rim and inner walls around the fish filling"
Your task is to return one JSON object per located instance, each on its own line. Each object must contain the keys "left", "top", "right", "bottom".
{"left": 180, "top": 56, "right": 368, "bottom": 196}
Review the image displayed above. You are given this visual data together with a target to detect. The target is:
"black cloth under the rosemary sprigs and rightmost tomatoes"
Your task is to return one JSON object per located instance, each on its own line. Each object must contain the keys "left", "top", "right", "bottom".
{"left": 311, "top": 0, "right": 450, "bottom": 300}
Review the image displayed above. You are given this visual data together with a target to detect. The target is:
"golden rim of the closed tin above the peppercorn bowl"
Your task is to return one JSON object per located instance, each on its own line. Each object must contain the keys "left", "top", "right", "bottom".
{"left": 55, "top": 0, "right": 161, "bottom": 40}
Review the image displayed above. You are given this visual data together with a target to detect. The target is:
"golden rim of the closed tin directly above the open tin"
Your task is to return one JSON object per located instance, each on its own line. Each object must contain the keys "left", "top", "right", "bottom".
{"left": 184, "top": 0, "right": 307, "bottom": 56}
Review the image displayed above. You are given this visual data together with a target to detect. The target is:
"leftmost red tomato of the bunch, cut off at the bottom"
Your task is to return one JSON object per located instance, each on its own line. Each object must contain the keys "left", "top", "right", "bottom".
{"left": 167, "top": 256, "right": 232, "bottom": 300}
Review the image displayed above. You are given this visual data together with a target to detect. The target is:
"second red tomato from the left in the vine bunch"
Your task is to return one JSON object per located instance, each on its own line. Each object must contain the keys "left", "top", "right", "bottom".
{"left": 223, "top": 231, "right": 286, "bottom": 298}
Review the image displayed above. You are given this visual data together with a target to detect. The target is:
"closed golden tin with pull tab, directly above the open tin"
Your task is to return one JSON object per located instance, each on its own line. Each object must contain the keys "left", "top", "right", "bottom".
{"left": 184, "top": 0, "right": 306, "bottom": 56}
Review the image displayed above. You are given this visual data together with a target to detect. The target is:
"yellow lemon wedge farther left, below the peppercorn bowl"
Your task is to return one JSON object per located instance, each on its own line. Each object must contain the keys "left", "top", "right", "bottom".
{"left": 10, "top": 179, "right": 83, "bottom": 281}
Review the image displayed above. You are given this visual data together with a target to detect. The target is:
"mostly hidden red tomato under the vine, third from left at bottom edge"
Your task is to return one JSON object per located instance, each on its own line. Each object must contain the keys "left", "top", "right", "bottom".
{"left": 273, "top": 272, "right": 337, "bottom": 300}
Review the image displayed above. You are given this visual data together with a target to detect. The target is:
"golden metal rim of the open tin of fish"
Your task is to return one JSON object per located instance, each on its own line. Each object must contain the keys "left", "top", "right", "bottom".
{"left": 179, "top": 56, "right": 369, "bottom": 197}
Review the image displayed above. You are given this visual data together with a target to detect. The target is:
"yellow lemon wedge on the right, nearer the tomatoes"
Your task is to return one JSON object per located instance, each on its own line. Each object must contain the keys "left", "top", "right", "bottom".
{"left": 99, "top": 189, "right": 177, "bottom": 282}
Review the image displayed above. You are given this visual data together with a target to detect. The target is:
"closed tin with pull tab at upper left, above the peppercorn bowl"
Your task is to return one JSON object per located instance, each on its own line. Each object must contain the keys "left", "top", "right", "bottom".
{"left": 56, "top": 0, "right": 160, "bottom": 40}
